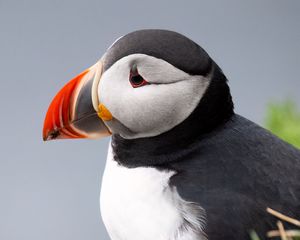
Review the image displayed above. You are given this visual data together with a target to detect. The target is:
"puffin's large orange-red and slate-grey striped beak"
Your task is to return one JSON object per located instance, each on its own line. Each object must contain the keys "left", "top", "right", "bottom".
{"left": 43, "top": 60, "right": 111, "bottom": 141}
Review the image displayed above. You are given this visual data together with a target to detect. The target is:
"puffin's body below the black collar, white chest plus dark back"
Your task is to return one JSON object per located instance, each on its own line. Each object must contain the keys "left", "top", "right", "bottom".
{"left": 101, "top": 114, "right": 300, "bottom": 240}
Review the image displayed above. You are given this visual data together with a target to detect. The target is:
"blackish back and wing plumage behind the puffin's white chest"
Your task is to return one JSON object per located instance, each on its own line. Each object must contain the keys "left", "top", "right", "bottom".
{"left": 167, "top": 115, "right": 300, "bottom": 240}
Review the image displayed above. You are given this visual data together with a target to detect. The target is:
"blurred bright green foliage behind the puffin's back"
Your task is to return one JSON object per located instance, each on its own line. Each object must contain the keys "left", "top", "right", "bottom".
{"left": 265, "top": 100, "right": 300, "bottom": 148}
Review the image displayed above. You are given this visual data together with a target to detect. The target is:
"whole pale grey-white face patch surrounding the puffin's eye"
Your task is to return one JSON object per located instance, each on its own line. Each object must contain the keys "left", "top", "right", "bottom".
{"left": 98, "top": 54, "right": 209, "bottom": 138}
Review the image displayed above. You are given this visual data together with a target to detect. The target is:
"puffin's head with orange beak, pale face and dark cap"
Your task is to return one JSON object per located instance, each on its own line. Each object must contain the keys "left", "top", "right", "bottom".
{"left": 43, "top": 30, "right": 232, "bottom": 147}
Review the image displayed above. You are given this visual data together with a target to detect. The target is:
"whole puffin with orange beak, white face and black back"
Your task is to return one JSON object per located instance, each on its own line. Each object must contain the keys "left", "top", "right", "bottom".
{"left": 43, "top": 29, "right": 300, "bottom": 240}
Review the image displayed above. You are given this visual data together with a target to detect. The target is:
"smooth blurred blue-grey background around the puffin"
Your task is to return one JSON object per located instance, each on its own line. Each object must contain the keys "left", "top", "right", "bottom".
{"left": 0, "top": 0, "right": 300, "bottom": 240}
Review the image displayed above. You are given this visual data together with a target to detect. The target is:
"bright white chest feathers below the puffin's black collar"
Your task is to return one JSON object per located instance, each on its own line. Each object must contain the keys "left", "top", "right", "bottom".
{"left": 100, "top": 143, "right": 203, "bottom": 240}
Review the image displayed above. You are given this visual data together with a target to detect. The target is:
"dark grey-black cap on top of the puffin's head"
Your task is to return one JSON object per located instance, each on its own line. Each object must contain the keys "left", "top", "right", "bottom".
{"left": 103, "top": 29, "right": 211, "bottom": 75}
